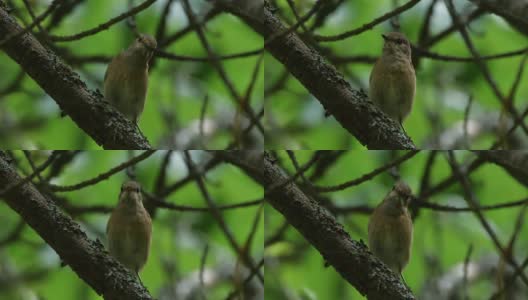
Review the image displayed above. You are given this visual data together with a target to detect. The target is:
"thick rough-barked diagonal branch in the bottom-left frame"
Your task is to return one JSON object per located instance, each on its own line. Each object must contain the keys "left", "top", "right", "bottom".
{"left": 0, "top": 152, "right": 152, "bottom": 300}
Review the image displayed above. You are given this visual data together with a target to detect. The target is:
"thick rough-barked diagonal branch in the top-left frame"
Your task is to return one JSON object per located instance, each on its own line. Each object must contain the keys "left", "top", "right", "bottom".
{"left": 0, "top": 2, "right": 151, "bottom": 149}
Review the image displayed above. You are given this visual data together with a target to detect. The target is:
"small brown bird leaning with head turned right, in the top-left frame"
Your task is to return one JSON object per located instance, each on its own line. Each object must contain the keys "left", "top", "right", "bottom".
{"left": 104, "top": 34, "right": 157, "bottom": 125}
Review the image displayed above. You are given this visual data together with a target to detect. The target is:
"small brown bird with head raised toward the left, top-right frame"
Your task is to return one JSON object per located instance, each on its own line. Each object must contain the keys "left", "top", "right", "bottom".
{"left": 369, "top": 32, "right": 416, "bottom": 128}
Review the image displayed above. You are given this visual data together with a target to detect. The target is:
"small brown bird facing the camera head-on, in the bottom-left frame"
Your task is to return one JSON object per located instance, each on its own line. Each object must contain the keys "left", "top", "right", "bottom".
{"left": 106, "top": 181, "right": 152, "bottom": 278}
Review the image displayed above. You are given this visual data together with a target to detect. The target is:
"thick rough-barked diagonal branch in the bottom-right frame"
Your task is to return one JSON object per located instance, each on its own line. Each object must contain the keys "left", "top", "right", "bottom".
{"left": 250, "top": 152, "right": 414, "bottom": 300}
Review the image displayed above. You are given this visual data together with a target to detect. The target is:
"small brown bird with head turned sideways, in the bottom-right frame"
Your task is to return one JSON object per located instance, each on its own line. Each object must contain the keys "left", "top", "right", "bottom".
{"left": 368, "top": 181, "right": 413, "bottom": 274}
